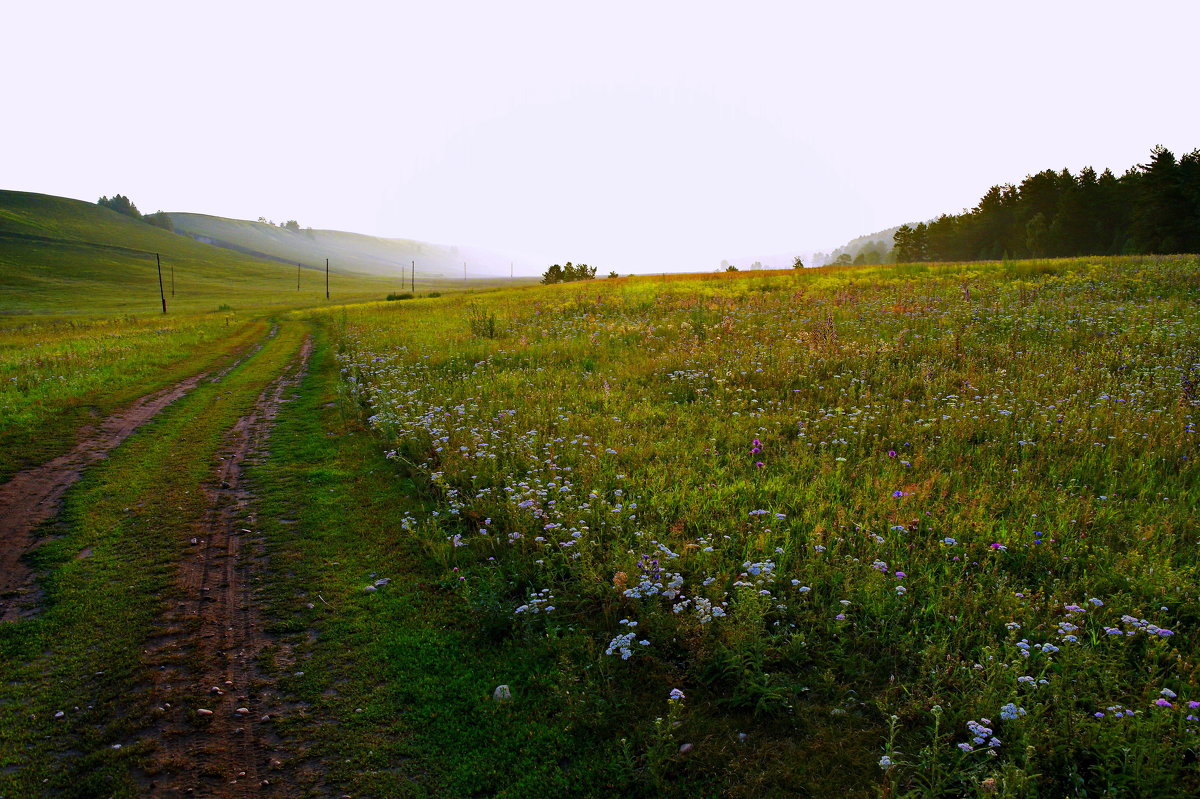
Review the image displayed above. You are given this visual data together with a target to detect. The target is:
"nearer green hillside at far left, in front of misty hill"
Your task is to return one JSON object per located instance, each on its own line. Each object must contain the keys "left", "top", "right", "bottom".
{"left": 0, "top": 191, "right": 396, "bottom": 314}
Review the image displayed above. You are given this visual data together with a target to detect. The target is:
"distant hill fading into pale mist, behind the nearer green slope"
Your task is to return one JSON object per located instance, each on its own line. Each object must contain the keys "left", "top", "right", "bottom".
{"left": 168, "top": 212, "right": 528, "bottom": 279}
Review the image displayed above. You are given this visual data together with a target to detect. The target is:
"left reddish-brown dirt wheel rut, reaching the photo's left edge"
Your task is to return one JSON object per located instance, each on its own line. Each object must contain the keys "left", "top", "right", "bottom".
{"left": 0, "top": 374, "right": 208, "bottom": 621}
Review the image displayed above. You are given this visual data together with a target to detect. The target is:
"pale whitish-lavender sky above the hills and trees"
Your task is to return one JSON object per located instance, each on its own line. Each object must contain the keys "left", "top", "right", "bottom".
{"left": 0, "top": 0, "right": 1200, "bottom": 274}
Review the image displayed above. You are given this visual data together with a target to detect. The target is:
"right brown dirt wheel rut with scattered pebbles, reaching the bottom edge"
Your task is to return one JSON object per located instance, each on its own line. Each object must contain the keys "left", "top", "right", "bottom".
{"left": 144, "top": 340, "right": 312, "bottom": 798}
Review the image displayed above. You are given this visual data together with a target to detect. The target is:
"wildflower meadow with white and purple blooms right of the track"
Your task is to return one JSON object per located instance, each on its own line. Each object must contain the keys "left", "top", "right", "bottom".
{"left": 331, "top": 257, "right": 1200, "bottom": 797}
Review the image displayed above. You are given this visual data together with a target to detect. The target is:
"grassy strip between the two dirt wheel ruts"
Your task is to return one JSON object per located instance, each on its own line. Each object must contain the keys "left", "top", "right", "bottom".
{"left": 0, "top": 324, "right": 304, "bottom": 797}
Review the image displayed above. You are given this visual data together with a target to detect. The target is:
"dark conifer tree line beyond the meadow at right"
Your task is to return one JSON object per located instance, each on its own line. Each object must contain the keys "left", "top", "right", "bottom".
{"left": 894, "top": 146, "right": 1200, "bottom": 263}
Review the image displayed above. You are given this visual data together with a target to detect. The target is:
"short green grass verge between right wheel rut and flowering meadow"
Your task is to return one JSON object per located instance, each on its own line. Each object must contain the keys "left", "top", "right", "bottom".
{"left": 251, "top": 321, "right": 648, "bottom": 797}
